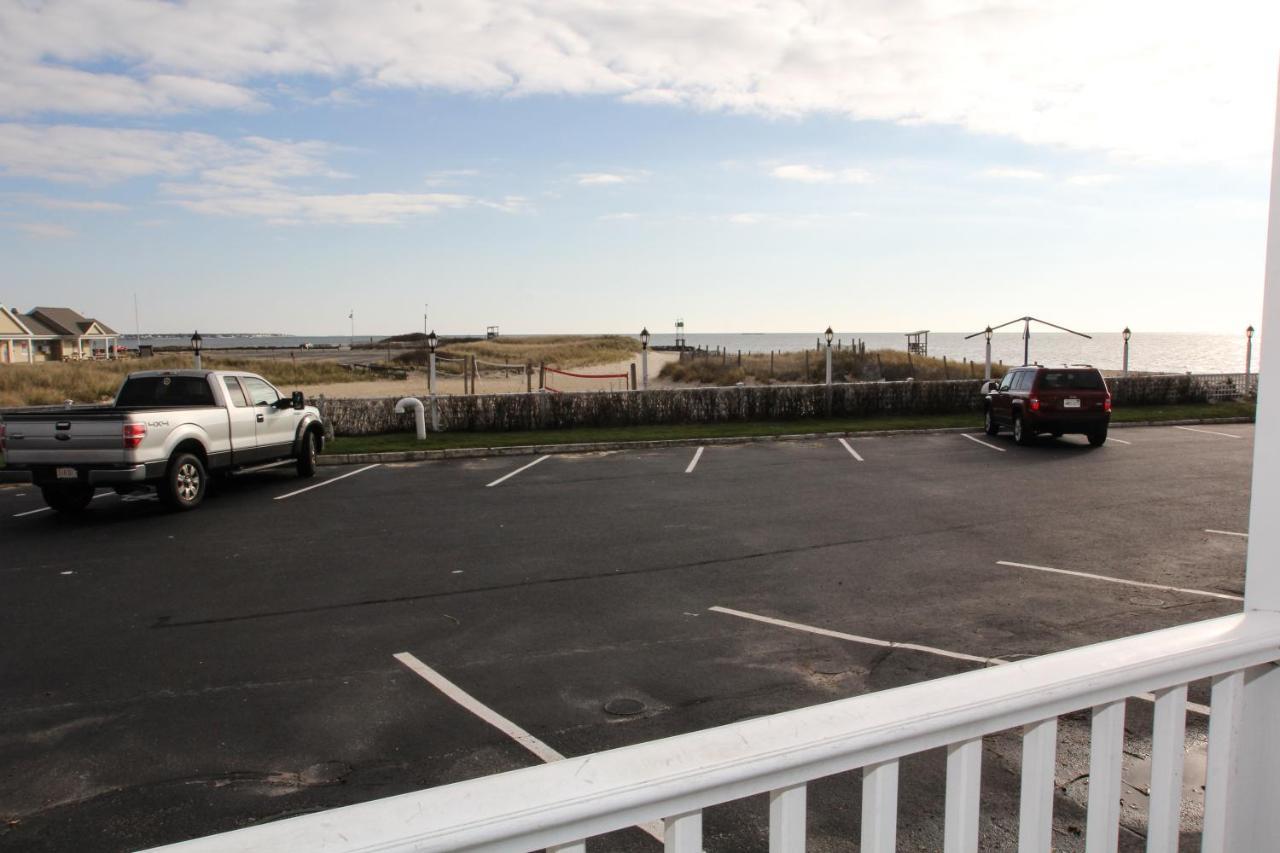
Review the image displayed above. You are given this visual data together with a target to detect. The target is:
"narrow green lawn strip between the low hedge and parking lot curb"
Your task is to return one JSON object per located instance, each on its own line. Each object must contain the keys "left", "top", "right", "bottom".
{"left": 324, "top": 401, "right": 1254, "bottom": 453}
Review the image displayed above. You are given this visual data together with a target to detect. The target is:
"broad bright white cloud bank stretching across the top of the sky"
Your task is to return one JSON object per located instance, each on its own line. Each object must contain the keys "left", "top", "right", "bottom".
{"left": 0, "top": 0, "right": 1280, "bottom": 163}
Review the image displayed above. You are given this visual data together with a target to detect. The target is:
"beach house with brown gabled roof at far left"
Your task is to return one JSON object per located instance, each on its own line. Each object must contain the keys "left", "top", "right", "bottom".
{"left": 0, "top": 305, "right": 119, "bottom": 364}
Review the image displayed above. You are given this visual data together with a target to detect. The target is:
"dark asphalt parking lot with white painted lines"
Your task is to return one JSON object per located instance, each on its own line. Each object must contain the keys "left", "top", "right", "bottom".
{"left": 0, "top": 425, "right": 1253, "bottom": 852}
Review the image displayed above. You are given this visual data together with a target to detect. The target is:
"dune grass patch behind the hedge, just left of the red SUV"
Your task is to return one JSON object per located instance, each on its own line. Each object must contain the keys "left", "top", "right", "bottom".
{"left": 658, "top": 350, "right": 1006, "bottom": 386}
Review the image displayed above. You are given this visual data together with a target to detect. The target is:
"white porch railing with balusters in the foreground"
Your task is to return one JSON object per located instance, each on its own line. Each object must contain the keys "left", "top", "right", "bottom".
{"left": 140, "top": 612, "right": 1280, "bottom": 853}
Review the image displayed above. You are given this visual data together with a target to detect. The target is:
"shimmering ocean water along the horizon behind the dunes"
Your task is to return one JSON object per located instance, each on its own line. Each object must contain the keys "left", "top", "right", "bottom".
{"left": 132, "top": 328, "right": 1261, "bottom": 373}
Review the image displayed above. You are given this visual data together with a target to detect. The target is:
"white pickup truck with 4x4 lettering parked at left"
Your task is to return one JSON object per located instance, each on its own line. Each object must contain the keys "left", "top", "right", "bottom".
{"left": 0, "top": 370, "right": 324, "bottom": 512}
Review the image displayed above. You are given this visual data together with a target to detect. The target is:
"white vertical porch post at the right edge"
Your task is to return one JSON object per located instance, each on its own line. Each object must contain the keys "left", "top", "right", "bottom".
{"left": 1226, "top": 58, "right": 1280, "bottom": 850}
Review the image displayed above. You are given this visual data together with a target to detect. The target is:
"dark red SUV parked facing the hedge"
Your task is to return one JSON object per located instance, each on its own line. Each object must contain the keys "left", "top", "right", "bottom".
{"left": 986, "top": 365, "right": 1111, "bottom": 447}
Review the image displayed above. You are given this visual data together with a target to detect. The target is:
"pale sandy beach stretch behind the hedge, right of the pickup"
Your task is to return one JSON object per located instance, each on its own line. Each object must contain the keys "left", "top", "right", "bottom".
{"left": 298, "top": 352, "right": 680, "bottom": 398}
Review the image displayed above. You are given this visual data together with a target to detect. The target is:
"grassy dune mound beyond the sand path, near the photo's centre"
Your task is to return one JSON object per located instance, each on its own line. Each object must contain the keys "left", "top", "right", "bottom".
{"left": 396, "top": 334, "right": 640, "bottom": 373}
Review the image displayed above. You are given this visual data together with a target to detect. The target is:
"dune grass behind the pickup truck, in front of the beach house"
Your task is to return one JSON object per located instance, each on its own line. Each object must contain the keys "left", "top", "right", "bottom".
{"left": 0, "top": 355, "right": 367, "bottom": 407}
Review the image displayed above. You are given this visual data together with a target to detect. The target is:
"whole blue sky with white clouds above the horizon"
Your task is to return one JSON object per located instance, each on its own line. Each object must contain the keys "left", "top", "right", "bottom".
{"left": 0, "top": 0, "right": 1280, "bottom": 336}
